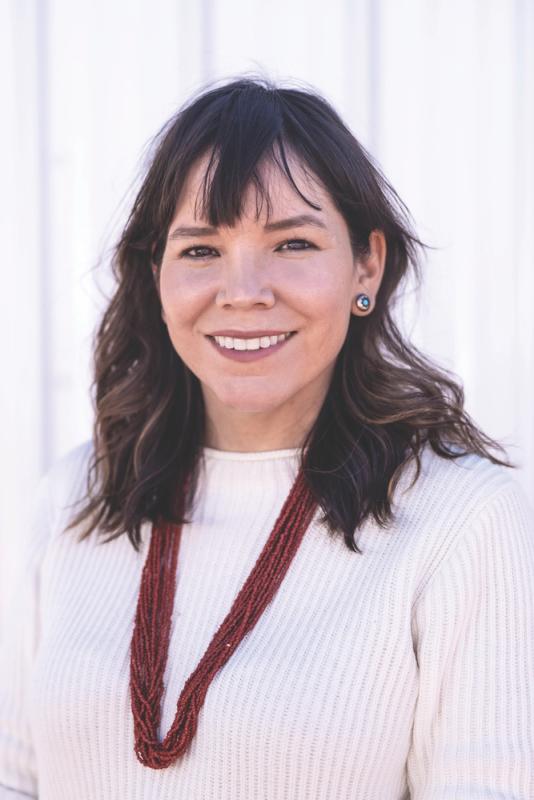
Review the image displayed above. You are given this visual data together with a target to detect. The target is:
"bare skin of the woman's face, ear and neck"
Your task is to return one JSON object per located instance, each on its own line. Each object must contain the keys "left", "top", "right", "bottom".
{"left": 159, "top": 149, "right": 386, "bottom": 452}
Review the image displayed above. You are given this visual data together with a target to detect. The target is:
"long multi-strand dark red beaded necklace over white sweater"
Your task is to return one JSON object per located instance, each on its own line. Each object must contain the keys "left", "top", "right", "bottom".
{"left": 130, "top": 470, "right": 317, "bottom": 769}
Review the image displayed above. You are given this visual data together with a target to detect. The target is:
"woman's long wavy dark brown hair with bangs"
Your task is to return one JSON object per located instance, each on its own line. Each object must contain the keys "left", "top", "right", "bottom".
{"left": 67, "top": 77, "right": 515, "bottom": 552}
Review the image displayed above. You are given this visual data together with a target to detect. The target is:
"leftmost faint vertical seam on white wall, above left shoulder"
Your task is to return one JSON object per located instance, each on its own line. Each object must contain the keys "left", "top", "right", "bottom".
{"left": 34, "top": 0, "right": 54, "bottom": 472}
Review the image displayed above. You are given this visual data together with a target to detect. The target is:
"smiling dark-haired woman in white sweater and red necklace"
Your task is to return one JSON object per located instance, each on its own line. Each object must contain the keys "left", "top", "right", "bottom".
{"left": 0, "top": 78, "right": 534, "bottom": 800}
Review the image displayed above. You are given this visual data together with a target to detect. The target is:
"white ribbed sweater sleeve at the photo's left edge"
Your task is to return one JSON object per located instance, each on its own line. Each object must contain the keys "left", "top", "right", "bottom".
{"left": 0, "top": 477, "right": 54, "bottom": 800}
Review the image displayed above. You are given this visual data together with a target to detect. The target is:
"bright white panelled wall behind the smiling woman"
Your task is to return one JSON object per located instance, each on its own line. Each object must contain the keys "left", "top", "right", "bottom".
{"left": 0, "top": 0, "right": 534, "bottom": 608}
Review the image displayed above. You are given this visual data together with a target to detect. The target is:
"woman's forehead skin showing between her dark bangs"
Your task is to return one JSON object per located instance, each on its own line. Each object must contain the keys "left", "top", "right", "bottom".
{"left": 175, "top": 148, "right": 336, "bottom": 221}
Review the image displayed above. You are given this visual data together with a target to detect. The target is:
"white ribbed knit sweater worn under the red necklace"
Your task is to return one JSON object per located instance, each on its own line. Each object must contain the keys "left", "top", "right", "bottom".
{"left": 0, "top": 443, "right": 534, "bottom": 800}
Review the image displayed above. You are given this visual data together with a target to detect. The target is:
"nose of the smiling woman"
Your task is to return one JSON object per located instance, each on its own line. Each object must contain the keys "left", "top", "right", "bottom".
{"left": 215, "top": 252, "right": 275, "bottom": 308}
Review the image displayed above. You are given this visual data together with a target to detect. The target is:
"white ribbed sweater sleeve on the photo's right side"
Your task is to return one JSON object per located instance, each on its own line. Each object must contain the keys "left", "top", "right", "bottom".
{"left": 407, "top": 480, "right": 534, "bottom": 800}
